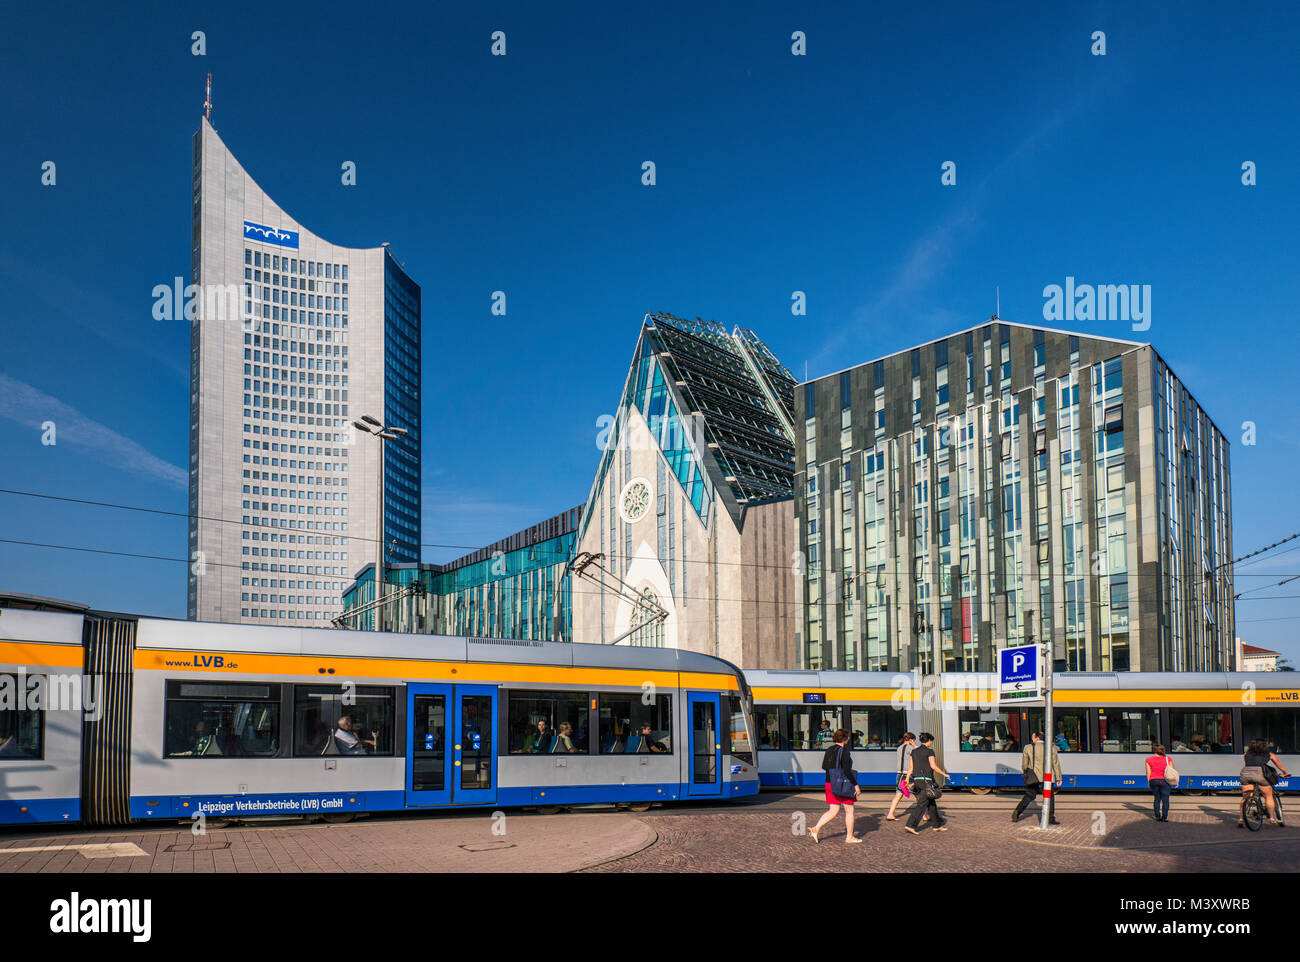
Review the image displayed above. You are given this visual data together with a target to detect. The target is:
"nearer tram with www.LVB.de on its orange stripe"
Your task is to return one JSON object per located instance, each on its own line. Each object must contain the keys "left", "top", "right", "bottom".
{"left": 0, "top": 608, "right": 758, "bottom": 826}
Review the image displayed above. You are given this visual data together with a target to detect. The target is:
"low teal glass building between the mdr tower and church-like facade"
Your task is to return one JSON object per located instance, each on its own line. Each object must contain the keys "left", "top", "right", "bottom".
{"left": 341, "top": 504, "right": 582, "bottom": 641}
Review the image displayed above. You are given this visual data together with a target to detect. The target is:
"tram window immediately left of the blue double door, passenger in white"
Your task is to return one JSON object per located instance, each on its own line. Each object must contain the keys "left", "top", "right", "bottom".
{"left": 294, "top": 685, "right": 397, "bottom": 758}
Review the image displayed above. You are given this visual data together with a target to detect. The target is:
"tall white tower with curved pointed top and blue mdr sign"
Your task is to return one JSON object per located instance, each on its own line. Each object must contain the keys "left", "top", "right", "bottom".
{"left": 187, "top": 117, "right": 421, "bottom": 625}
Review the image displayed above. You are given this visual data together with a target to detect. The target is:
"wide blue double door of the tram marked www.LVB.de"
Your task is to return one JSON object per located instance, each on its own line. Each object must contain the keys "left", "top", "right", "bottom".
{"left": 406, "top": 683, "right": 497, "bottom": 806}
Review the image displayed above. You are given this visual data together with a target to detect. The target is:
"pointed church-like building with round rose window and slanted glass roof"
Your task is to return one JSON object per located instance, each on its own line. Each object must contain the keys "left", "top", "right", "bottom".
{"left": 571, "top": 313, "right": 800, "bottom": 668}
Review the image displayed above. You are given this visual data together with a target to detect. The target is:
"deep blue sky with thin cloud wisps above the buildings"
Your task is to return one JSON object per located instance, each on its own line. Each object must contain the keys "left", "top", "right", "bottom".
{"left": 0, "top": 3, "right": 1300, "bottom": 658}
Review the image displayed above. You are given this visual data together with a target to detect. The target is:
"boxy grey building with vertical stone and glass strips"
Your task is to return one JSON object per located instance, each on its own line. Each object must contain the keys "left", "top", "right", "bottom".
{"left": 796, "top": 317, "right": 1235, "bottom": 671}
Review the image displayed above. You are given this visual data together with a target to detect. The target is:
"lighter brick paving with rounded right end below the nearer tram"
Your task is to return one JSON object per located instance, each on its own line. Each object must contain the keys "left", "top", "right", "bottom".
{"left": 0, "top": 811, "right": 657, "bottom": 874}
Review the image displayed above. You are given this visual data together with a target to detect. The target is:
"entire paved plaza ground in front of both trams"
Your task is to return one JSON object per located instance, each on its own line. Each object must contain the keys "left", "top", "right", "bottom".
{"left": 0, "top": 792, "right": 1300, "bottom": 874}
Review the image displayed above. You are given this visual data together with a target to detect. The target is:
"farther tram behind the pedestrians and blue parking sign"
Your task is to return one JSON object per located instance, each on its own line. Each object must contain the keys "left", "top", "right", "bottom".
{"left": 745, "top": 671, "right": 1300, "bottom": 794}
